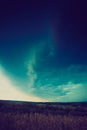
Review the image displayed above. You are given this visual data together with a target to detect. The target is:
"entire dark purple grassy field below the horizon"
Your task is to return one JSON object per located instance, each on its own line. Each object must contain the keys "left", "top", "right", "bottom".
{"left": 0, "top": 101, "right": 87, "bottom": 130}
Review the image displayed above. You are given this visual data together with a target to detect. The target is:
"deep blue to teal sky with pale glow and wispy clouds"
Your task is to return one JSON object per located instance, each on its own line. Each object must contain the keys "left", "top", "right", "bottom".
{"left": 0, "top": 0, "right": 87, "bottom": 102}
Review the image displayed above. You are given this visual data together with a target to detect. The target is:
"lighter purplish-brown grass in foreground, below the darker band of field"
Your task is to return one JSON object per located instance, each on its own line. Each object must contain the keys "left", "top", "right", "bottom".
{"left": 0, "top": 113, "right": 87, "bottom": 130}
